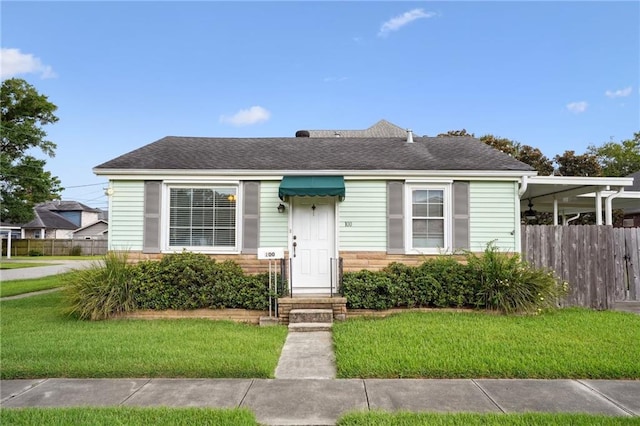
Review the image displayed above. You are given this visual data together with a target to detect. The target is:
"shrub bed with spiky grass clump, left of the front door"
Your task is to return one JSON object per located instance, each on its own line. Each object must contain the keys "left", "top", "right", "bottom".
{"left": 67, "top": 252, "right": 277, "bottom": 320}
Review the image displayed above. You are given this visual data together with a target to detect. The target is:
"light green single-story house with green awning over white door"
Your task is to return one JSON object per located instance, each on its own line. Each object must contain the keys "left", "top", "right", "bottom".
{"left": 94, "top": 129, "right": 536, "bottom": 294}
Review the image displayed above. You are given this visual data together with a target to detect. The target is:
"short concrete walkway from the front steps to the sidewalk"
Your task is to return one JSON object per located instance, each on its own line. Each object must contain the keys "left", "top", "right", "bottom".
{"left": 275, "top": 331, "right": 336, "bottom": 379}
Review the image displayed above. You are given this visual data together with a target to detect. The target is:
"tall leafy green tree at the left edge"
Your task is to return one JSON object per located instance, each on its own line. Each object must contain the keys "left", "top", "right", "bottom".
{"left": 0, "top": 78, "right": 62, "bottom": 223}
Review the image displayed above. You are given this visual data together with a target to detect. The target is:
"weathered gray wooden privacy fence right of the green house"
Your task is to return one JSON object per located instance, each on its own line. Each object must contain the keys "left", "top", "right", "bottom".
{"left": 521, "top": 225, "right": 640, "bottom": 309}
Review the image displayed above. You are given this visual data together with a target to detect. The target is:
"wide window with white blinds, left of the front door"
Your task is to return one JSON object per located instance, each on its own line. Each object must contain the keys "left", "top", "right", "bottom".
{"left": 169, "top": 188, "right": 238, "bottom": 248}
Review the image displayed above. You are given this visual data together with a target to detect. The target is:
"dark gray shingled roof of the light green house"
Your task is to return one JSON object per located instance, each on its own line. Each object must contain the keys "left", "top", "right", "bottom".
{"left": 95, "top": 136, "right": 533, "bottom": 172}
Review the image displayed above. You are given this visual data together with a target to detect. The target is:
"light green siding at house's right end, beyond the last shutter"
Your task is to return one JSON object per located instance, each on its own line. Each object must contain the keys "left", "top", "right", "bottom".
{"left": 469, "top": 181, "right": 520, "bottom": 252}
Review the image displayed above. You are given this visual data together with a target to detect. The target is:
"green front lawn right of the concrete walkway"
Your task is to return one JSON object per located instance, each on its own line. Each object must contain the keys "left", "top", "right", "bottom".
{"left": 333, "top": 309, "right": 640, "bottom": 379}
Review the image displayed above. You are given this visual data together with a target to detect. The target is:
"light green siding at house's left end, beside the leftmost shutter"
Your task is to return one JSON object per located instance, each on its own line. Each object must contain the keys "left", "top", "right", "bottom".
{"left": 109, "top": 180, "right": 144, "bottom": 250}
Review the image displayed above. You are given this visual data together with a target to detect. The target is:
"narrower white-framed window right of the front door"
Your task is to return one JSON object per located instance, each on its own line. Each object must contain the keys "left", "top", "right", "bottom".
{"left": 405, "top": 185, "right": 450, "bottom": 253}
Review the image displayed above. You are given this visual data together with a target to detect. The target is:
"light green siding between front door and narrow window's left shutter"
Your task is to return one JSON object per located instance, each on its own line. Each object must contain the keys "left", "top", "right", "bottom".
{"left": 337, "top": 180, "right": 387, "bottom": 251}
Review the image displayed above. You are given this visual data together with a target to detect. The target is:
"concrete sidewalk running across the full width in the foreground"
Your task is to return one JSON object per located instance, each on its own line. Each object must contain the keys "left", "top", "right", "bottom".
{"left": 0, "top": 379, "right": 640, "bottom": 425}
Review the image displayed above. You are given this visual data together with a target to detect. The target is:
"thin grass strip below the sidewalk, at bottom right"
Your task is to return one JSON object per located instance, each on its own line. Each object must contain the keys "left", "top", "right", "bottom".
{"left": 337, "top": 412, "right": 640, "bottom": 426}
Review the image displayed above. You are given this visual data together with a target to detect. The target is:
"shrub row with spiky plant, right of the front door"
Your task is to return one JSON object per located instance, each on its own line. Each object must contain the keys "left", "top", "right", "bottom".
{"left": 342, "top": 244, "right": 566, "bottom": 313}
